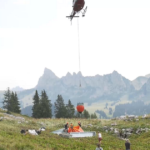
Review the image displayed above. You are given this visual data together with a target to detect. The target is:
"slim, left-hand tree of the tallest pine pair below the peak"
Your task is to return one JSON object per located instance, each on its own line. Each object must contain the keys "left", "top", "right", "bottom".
{"left": 32, "top": 90, "right": 40, "bottom": 118}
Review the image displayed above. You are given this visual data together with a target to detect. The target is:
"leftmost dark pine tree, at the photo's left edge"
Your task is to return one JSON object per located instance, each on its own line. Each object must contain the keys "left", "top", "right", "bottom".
{"left": 3, "top": 88, "right": 11, "bottom": 112}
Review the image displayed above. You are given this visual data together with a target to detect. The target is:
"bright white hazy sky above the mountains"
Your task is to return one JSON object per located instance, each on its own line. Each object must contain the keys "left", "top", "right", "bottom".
{"left": 0, "top": 0, "right": 150, "bottom": 90}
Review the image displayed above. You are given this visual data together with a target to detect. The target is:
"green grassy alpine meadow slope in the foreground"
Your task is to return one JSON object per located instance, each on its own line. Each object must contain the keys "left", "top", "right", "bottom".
{"left": 0, "top": 110, "right": 150, "bottom": 150}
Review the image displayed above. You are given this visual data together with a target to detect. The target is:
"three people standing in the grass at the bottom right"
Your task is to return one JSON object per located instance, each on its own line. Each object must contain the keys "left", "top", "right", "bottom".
{"left": 95, "top": 132, "right": 130, "bottom": 150}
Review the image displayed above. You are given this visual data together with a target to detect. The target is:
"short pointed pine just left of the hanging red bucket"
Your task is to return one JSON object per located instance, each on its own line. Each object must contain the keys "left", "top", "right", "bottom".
{"left": 66, "top": 100, "right": 75, "bottom": 118}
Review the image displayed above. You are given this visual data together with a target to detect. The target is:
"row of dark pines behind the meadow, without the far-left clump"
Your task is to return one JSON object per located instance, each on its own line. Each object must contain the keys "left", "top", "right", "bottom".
{"left": 32, "top": 90, "right": 97, "bottom": 119}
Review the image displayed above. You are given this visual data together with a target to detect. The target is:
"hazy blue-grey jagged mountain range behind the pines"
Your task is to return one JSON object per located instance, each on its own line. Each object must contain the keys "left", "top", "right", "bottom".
{"left": 0, "top": 68, "right": 150, "bottom": 115}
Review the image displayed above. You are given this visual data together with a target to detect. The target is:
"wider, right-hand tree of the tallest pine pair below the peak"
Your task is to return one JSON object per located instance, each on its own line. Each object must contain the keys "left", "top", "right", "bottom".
{"left": 40, "top": 90, "right": 52, "bottom": 118}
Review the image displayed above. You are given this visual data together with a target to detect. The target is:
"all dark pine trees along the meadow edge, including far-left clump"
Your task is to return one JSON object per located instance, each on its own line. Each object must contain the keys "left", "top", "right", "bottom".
{"left": 3, "top": 88, "right": 97, "bottom": 119}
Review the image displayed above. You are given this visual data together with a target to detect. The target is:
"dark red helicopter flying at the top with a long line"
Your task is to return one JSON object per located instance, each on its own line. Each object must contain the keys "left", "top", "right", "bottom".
{"left": 66, "top": 0, "right": 87, "bottom": 21}
